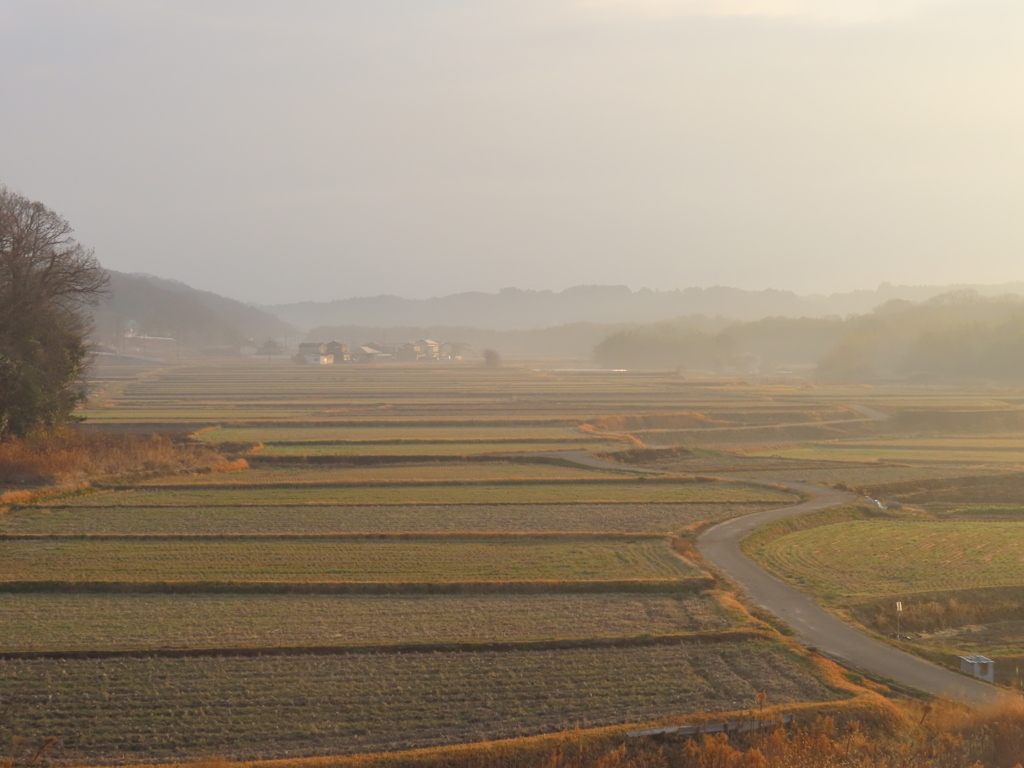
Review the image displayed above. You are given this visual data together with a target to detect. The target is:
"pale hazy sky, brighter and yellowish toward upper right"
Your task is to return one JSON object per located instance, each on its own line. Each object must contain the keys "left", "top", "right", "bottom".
{"left": 0, "top": 0, "right": 1024, "bottom": 302}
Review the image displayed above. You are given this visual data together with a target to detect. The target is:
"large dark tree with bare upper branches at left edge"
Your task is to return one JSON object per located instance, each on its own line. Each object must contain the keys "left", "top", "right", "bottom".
{"left": 0, "top": 186, "right": 108, "bottom": 439}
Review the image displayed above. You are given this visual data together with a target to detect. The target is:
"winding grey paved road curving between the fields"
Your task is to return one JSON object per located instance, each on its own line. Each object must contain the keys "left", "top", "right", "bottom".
{"left": 550, "top": 451, "right": 1006, "bottom": 705}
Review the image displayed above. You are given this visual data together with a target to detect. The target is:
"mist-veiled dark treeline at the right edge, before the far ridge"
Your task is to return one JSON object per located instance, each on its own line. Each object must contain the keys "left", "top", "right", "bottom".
{"left": 594, "top": 291, "right": 1024, "bottom": 381}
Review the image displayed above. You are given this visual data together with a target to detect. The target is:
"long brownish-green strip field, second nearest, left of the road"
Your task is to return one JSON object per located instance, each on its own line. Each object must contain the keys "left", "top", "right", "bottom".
{"left": 0, "top": 593, "right": 734, "bottom": 652}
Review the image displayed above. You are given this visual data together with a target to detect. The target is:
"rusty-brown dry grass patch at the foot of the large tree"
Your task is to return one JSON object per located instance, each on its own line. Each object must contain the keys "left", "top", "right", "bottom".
{"left": 0, "top": 429, "right": 232, "bottom": 495}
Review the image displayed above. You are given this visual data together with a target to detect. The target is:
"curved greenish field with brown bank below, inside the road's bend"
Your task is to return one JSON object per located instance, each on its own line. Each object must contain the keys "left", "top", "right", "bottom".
{"left": 754, "top": 515, "right": 1024, "bottom": 688}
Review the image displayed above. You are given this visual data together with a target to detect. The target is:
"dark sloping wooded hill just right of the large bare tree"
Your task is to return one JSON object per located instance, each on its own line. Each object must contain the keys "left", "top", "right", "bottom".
{"left": 93, "top": 270, "right": 298, "bottom": 349}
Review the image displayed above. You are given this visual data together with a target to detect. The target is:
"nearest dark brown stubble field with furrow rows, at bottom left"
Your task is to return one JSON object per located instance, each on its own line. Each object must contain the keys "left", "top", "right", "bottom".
{"left": 0, "top": 642, "right": 837, "bottom": 764}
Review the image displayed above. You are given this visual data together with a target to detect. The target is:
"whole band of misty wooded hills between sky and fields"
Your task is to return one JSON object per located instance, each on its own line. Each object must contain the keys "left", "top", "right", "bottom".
{"left": 94, "top": 272, "right": 1024, "bottom": 381}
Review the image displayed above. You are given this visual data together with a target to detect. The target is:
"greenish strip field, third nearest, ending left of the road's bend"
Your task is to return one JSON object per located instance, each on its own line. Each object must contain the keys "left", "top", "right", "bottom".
{"left": 0, "top": 536, "right": 698, "bottom": 584}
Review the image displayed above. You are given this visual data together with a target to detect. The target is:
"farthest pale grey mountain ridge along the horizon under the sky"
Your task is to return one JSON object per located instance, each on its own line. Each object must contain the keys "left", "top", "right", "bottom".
{"left": 262, "top": 283, "right": 1024, "bottom": 331}
